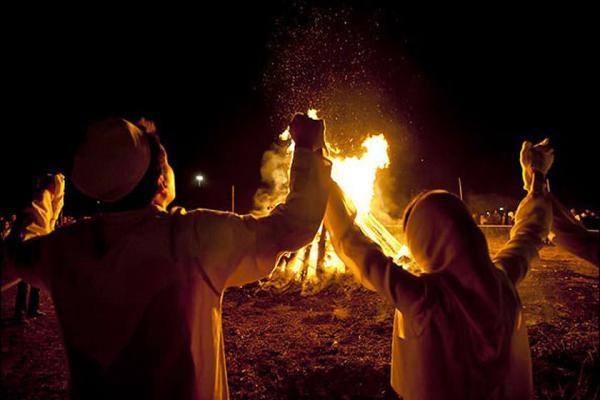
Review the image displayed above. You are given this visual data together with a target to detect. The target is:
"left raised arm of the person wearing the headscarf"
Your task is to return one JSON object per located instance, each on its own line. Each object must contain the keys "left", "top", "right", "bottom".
{"left": 325, "top": 184, "right": 425, "bottom": 312}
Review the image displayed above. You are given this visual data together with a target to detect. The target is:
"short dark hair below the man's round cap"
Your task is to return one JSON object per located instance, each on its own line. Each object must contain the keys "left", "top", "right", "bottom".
{"left": 102, "top": 132, "right": 167, "bottom": 212}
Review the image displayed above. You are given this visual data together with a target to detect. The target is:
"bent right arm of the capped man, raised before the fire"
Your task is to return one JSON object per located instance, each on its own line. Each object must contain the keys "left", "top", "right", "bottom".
{"left": 190, "top": 114, "right": 330, "bottom": 291}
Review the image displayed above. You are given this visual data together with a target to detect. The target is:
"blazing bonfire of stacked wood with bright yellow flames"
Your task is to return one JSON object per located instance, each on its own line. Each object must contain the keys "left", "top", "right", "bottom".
{"left": 254, "top": 110, "right": 408, "bottom": 295}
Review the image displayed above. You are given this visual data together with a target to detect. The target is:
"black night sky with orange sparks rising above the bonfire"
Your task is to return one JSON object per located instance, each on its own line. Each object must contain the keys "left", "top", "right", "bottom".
{"left": 0, "top": 2, "right": 600, "bottom": 214}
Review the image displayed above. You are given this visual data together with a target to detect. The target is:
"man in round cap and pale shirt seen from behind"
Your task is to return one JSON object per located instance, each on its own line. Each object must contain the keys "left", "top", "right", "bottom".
{"left": 1, "top": 114, "right": 330, "bottom": 399}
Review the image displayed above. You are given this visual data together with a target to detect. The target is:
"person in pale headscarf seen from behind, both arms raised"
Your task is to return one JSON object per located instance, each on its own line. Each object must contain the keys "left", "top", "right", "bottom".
{"left": 325, "top": 139, "right": 552, "bottom": 400}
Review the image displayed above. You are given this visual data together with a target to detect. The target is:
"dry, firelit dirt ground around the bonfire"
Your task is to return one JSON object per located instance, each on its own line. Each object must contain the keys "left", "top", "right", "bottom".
{"left": 0, "top": 235, "right": 600, "bottom": 400}
